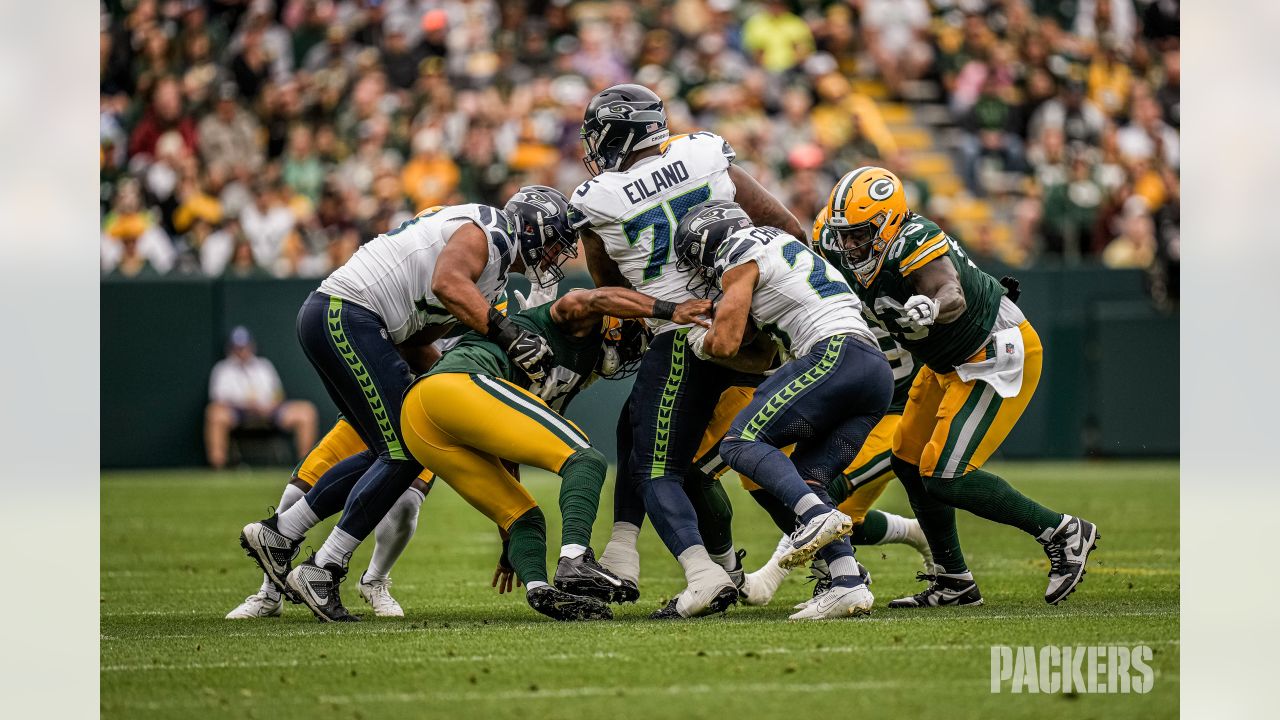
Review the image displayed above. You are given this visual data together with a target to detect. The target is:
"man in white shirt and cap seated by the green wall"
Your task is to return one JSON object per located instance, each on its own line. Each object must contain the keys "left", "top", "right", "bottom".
{"left": 205, "top": 325, "right": 317, "bottom": 470}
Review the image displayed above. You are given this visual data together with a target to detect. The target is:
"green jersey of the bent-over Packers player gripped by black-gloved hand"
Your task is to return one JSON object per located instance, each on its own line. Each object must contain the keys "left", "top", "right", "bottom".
{"left": 426, "top": 302, "right": 604, "bottom": 413}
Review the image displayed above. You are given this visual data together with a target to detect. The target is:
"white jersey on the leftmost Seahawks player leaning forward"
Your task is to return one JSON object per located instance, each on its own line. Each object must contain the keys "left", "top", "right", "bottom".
{"left": 320, "top": 205, "right": 516, "bottom": 343}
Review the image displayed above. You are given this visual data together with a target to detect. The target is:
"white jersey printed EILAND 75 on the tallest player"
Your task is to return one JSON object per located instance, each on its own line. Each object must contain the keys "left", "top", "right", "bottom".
{"left": 568, "top": 132, "right": 736, "bottom": 332}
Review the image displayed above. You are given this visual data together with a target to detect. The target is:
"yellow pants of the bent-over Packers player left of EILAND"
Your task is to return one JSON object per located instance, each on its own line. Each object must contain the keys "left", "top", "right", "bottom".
{"left": 401, "top": 373, "right": 590, "bottom": 530}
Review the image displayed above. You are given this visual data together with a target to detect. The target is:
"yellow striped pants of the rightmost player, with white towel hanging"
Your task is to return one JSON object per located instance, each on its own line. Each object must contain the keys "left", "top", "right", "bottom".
{"left": 893, "top": 320, "right": 1044, "bottom": 478}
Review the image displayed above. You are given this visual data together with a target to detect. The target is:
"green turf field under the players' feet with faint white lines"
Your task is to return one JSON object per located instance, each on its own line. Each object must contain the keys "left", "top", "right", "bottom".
{"left": 101, "top": 462, "right": 1179, "bottom": 720}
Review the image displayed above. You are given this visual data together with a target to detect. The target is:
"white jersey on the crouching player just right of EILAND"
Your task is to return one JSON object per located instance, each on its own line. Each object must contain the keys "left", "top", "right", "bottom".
{"left": 716, "top": 227, "right": 879, "bottom": 357}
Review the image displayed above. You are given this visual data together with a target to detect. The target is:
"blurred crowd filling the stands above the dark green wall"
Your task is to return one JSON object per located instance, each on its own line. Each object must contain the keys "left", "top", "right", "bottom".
{"left": 100, "top": 0, "right": 1179, "bottom": 297}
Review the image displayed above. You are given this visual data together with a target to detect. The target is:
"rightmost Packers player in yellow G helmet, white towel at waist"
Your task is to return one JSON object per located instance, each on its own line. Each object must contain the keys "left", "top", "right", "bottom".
{"left": 820, "top": 167, "right": 1098, "bottom": 607}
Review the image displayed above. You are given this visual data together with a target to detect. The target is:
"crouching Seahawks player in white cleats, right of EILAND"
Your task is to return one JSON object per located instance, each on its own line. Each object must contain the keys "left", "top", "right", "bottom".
{"left": 676, "top": 200, "right": 893, "bottom": 620}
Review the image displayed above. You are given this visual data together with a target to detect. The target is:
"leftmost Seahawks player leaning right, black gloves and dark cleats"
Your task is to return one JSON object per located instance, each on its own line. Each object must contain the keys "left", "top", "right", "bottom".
{"left": 241, "top": 186, "right": 577, "bottom": 621}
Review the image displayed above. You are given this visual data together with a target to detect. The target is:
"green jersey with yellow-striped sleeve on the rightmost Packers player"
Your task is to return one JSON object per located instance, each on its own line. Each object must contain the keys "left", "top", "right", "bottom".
{"left": 837, "top": 213, "right": 1005, "bottom": 373}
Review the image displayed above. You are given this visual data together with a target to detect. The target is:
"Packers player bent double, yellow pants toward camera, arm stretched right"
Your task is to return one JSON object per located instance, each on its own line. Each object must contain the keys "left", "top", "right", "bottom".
{"left": 401, "top": 287, "right": 710, "bottom": 620}
